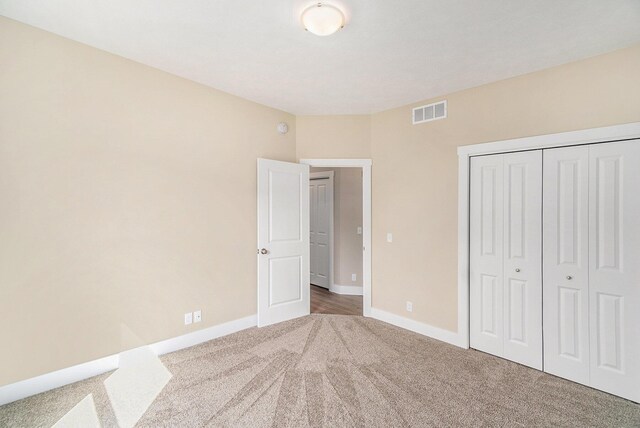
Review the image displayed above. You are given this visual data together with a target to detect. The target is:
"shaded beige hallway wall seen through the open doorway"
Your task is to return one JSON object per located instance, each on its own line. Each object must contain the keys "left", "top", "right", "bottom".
{"left": 311, "top": 168, "right": 362, "bottom": 287}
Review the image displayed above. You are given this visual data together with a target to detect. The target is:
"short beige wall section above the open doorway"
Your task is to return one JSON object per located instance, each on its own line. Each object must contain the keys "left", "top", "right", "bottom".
{"left": 296, "top": 115, "right": 371, "bottom": 159}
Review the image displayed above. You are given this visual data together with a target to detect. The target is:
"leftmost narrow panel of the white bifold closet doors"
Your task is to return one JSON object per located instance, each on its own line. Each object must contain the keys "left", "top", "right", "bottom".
{"left": 469, "top": 155, "right": 504, "bottom": 356}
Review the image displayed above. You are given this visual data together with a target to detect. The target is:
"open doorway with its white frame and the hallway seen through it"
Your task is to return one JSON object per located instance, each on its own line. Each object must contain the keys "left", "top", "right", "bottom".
{"left": 300, "top": 159, "right": 371, "bottom": 316}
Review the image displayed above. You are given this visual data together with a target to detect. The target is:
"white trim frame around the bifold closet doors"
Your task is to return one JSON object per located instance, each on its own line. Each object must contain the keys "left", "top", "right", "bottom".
{"left": 456, "top": 122, "right": 640, "bottom": 348}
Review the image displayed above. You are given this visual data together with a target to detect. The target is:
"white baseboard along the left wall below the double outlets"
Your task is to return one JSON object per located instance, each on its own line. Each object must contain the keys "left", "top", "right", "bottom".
{"left": 0, "top": 315, "right": 257, "bottom": 406}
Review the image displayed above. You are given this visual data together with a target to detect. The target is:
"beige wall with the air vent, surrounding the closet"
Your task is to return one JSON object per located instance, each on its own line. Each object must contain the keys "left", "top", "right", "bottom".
{"left": 371, "top": 45, "right": 640, "bottom": 331}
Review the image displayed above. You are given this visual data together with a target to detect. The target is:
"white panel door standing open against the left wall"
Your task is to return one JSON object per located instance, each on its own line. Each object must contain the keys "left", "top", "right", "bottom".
{"left": 258, "top": 159, "right": 310, "bottom": 327}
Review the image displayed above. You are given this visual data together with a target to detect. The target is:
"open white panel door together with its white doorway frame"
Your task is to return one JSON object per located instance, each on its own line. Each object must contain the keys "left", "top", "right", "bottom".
{"left": 257, "top": 159, "right": 371, "bottom": 327}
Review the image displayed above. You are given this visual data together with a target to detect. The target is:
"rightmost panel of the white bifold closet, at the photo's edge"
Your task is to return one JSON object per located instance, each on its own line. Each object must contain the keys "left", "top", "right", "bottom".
{"left": 589, "top": 140, "right": 640, "bottom": 401}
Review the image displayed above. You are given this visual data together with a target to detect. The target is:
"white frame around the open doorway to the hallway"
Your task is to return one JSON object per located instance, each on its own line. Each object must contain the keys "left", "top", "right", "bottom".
{"left": 299, "top": 159, "right": 372, "bottom": 317}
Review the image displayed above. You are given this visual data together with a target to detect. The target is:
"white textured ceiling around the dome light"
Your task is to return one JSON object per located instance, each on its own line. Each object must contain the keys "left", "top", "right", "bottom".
{"left": 0, "top": 0, "right": 640, "bottom": 114}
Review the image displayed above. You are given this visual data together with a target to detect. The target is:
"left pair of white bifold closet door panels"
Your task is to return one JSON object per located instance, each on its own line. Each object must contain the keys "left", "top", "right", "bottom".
{"left": 469, "top": 150, "right": 542, "bottom": 369}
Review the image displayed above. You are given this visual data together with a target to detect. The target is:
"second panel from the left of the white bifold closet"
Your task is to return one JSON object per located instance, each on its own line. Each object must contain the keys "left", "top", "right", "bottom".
{"left": 503, "top": 150, "right": 542, "bottom": 370}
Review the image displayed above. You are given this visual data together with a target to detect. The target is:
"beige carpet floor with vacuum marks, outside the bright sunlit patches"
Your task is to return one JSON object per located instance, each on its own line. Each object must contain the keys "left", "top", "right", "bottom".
{"left": 0, "top": 315, "right": 640, "bottom": 428}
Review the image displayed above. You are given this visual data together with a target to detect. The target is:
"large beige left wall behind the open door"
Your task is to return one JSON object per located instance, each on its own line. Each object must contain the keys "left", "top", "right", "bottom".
{"left": 0, "top": 18, "right": 295, "bottom": 385}
